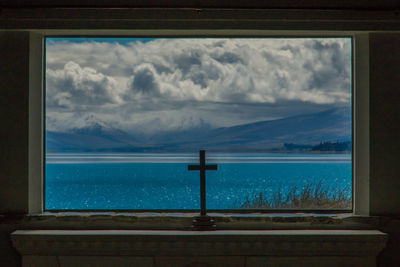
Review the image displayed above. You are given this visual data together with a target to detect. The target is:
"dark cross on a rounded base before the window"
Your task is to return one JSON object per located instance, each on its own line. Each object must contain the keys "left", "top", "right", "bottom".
{"left": 188, "top": 150, "right": 218, "bottom": 230}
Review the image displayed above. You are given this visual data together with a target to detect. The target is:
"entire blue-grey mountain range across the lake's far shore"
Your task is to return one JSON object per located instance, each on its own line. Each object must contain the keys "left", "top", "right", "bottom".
{"left": 46, "top": 109, "right": 351, "bottom": 152}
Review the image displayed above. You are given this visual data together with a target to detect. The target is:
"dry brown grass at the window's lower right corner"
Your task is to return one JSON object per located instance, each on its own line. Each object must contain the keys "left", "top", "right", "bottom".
{"left": 234, "top": 183, "right": 351, "bottom": 209}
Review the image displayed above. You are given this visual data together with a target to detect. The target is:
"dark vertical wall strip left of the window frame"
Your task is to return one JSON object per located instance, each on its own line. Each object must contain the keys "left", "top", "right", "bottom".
{"left": 0, "top": 31, "right": 29, "bottom": 216}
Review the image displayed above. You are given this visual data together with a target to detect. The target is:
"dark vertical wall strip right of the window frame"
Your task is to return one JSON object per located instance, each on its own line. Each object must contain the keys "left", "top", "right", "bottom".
{"left": 369, "top": 33, "right": 400, "bottom": 218}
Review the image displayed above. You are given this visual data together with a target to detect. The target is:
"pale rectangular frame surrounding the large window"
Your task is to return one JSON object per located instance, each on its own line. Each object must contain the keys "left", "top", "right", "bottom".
{"left": 29, "top": 30, "right": 369, "bottom": 215}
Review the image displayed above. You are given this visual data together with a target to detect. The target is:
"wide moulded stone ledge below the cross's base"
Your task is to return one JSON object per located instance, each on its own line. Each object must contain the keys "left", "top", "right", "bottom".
{"left": 11, "top": 230, "right": 387, "bottom": 256}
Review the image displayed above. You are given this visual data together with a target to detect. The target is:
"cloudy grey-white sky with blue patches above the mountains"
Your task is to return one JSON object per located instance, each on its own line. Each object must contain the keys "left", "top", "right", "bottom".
{"left": 46, "top": 38, "right": 352, "bottom": 134}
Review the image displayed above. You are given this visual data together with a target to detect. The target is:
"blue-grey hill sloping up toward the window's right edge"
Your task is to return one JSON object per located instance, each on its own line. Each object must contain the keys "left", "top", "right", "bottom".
{"left": 196, "top": 109, "right": 351, "bottom": 150}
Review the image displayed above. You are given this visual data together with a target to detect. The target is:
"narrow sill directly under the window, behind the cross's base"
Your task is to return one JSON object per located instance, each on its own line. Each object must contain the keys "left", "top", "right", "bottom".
{"left": 18, "top": 212, "right": 380, "bottom": 230}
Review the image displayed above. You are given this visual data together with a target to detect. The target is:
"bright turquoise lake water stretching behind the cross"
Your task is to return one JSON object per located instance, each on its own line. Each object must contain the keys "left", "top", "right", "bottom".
{"left": 45, "top": 153, "right": 352, "bottom": 210}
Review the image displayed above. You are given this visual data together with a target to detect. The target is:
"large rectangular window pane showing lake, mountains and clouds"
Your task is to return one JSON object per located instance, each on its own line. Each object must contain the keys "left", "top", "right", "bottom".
{"left": 44, "top": 36, "right": 353, "bottom": 211}
